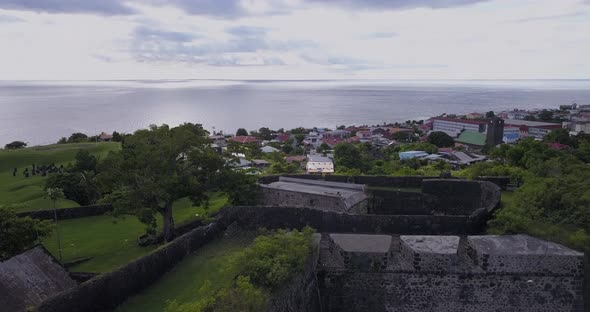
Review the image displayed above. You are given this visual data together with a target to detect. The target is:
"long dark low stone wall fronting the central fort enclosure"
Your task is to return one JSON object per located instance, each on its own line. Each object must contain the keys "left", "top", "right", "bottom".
{"left": 219, "top": 206, "right": 481, "bottom": 235}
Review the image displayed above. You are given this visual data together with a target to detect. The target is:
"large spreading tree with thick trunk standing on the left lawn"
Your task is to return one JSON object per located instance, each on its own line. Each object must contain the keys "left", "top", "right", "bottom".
{"left": 98, "top": 123, "right": 224, "bottom": 241}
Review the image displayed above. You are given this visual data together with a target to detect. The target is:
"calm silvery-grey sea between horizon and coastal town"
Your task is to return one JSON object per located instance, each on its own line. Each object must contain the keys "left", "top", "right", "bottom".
{"left": 0, "top": 80, "right": 590, "bottom": 146}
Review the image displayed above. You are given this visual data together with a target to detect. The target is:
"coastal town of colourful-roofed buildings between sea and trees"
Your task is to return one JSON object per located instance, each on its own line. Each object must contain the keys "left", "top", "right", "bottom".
{"left": 169, "top": 103, "right": 590, "bottom": 174}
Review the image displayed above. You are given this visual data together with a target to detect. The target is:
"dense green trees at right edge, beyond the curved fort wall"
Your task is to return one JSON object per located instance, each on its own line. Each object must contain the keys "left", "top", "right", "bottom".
{"left": 470, "top": 135, "right": 590, "bottom": 251}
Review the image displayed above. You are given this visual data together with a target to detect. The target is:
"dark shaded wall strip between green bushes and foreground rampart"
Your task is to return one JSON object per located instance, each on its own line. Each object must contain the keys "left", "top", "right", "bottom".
{"left": 267, "top": 234, "right": 321, "bottom": 312}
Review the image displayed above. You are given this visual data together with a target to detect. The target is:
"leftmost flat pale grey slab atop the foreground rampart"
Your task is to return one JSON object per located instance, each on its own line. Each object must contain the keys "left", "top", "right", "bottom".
{"left": 330, "top": 234, "right": 391, "bottom": 253}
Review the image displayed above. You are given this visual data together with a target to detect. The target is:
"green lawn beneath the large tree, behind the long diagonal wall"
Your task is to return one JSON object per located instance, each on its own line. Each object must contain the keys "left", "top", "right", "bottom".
{"left": 44, "top": 193, "right": 227, "bottom": 273}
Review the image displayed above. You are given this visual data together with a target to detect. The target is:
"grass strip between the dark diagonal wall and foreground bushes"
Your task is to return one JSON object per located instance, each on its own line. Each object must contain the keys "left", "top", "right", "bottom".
{"left": 115, "top": 234, "right": 255, "bottom": 312}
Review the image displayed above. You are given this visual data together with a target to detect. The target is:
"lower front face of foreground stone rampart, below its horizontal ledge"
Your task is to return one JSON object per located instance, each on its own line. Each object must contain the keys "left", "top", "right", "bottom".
{"left": 320, "top": 272, "right": 583, "bottom": 312}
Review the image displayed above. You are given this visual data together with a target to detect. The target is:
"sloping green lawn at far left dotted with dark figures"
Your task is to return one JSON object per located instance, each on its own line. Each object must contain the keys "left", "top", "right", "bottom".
{"left": 0, "top": 142, "right": 121, "bottom": 212}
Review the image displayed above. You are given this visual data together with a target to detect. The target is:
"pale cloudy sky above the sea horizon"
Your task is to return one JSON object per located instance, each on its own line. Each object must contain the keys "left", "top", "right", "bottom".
{"left": 0, "top": 0, "right": 590, "bottom": 80}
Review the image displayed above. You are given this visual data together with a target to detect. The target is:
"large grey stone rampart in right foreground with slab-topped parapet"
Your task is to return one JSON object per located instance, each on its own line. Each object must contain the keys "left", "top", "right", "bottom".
{"left": 318, "top": 235, "right": 584, "bottom": 312}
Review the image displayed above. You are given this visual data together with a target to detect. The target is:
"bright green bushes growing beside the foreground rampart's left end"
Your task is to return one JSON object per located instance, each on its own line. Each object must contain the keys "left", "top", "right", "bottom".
{"left": 166, "top": 227, "right": 314, "bottom": 312}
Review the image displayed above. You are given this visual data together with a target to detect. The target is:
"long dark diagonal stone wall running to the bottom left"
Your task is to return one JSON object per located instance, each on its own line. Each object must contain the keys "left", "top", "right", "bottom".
{"left": 33, "top": 220, "right": 228, "bottom": 312}
